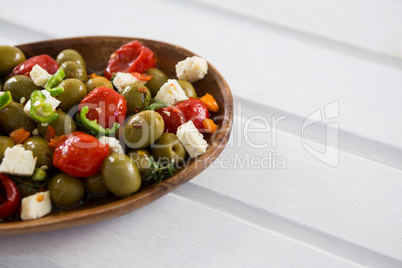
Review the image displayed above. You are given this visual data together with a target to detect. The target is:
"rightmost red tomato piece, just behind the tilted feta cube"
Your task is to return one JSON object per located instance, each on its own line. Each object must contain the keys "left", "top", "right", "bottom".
{"left": 156, "top": 98, "right": 209, "bottom": 134}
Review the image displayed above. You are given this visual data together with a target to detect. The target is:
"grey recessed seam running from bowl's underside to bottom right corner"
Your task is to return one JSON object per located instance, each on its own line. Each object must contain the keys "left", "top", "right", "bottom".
{"left": 169, "top": 182, "right": 402, "bottom": 267}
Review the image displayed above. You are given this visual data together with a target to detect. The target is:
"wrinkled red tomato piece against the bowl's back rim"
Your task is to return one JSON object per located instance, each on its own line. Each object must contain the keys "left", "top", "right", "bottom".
{"left": 105, "top": 40, "right": 156, "bottom": 79}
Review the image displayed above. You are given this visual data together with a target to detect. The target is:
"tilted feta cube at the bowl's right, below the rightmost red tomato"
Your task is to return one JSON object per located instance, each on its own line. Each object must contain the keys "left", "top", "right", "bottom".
{"left": 176, "top": 121, "right": 208, "bottom": 158}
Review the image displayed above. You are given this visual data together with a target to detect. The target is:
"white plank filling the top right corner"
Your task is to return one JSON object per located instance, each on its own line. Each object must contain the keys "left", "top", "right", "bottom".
{"left": 182, "top": 0, "right": 402, "bottom": 59}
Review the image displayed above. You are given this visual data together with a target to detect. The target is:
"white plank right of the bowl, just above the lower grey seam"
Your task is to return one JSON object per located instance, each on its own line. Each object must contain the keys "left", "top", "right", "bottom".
{"left": 193, "top": 109, "right": 402, "bottom": 261}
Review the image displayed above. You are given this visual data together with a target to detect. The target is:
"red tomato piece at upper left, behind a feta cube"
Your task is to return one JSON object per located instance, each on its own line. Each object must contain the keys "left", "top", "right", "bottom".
{"left": 11, "top": 54, "right": 59, "bottom": 76}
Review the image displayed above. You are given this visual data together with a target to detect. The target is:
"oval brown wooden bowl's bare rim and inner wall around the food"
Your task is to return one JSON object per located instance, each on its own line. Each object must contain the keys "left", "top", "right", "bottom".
{"left": 0, "top": 36, "right": 233, "bottom": 235}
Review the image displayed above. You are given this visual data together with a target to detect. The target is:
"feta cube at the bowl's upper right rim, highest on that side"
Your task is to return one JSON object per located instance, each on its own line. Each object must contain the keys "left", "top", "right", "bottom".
{"left": 176, "top": 56, "right": 208, "bottom": 82}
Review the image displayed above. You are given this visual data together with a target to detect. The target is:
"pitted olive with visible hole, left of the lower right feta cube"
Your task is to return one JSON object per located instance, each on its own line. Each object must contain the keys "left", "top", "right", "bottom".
{"left": 151, "top": 133, "right": 186, "bottom": 163}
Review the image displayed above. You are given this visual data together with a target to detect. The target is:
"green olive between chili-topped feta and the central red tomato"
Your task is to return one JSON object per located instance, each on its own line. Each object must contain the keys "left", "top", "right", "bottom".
{"left": 56, "top": 78, "right": 87, "bottom": 113}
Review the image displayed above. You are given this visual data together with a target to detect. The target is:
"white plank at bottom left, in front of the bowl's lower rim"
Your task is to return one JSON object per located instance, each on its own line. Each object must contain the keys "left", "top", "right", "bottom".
{"left": 0, "top": 195, "right": 372, "bottom": 267}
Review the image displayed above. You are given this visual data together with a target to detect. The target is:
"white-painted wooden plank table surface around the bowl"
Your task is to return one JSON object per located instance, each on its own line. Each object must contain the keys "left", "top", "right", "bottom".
{"left": 0, "top": 0, "right": 402, "bottom": 267}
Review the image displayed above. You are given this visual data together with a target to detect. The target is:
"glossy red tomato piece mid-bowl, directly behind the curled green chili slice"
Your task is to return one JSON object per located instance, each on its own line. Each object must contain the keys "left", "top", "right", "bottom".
{"left": 79, "top": 87, "right": 127, "bottom": 128}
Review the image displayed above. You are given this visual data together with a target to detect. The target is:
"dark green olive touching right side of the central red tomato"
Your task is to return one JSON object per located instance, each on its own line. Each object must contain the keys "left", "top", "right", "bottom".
{"left": 121, "top": 83, "right": 151, "bottom": 115}
